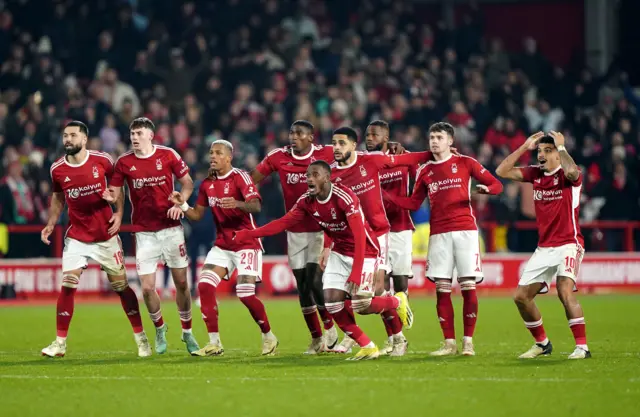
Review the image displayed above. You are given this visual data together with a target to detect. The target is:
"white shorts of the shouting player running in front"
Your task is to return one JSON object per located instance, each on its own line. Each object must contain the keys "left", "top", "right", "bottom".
{"left": 322, "top": 251, "right": 378, "bottom": 297}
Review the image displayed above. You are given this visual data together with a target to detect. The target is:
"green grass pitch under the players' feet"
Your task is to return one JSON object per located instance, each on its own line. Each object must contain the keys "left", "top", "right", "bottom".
{"left": 0, "top": 295, "right": 640, "bottom": 417}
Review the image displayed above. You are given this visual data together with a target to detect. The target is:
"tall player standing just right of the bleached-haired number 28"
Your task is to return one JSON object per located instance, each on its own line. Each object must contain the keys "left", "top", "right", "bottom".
{"left": 251, "top": 120, "right": 338, "bottom": 355}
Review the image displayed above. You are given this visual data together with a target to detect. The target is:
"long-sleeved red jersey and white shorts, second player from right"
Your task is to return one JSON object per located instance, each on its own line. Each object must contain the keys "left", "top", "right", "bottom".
{"left": 411, "top": 155, "right": 502, "bottom": 282}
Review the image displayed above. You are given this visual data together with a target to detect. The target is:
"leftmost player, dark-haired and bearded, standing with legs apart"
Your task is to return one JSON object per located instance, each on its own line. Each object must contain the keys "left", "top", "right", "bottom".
{"left": 41, "top": 121, "right": 151, "bottom": 357}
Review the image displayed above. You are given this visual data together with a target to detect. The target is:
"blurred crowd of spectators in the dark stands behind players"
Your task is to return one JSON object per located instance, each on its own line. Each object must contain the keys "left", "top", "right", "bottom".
{"left": 0, "top": 0, "right": 640, "bottom": 256}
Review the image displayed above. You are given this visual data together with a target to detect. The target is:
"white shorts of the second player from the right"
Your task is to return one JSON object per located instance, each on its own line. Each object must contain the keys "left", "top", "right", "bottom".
{"left": 425, "top": 230, "right": 484, "bottom": 282}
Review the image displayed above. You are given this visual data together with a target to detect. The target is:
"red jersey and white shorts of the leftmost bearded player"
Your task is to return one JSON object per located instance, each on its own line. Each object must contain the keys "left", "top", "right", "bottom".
{"left": 50, "top": 151, "right": 124, "bottom": 275}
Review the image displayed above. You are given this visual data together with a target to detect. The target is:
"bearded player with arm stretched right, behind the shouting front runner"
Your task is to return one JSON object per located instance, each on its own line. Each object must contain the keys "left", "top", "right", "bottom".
{"left": 323, "top": 127, "right": 432, "bottom": 354}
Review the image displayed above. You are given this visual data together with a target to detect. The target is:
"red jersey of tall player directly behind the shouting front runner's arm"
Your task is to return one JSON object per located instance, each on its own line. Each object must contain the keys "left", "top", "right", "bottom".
{"left": 256, "top": 145, "right": 333, "bottom": 233}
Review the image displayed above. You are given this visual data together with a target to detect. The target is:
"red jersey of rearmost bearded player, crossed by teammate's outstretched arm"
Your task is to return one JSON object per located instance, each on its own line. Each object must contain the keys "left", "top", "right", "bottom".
{"left": 380, "top": 153, "right": 417, "bottom": 232}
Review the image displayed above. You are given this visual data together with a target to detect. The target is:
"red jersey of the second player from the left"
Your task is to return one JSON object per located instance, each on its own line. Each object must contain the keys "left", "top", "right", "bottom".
{"left": 109, "top": 145, "right": 189, "bottom": 232}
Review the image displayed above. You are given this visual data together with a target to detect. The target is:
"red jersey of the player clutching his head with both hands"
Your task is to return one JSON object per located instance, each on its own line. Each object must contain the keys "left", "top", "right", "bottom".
{"left": 521, "top": 166, "right": 584, "bottom": 248}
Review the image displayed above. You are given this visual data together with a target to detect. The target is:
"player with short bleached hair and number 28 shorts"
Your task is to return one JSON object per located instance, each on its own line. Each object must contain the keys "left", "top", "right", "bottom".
{"left": 169, "top": 140, "right": 278, "bottom": 356}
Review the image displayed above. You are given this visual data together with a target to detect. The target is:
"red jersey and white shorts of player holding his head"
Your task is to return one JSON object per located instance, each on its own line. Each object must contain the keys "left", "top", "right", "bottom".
{"left": 519, "top": 166, "right": 584, "bottom": 293}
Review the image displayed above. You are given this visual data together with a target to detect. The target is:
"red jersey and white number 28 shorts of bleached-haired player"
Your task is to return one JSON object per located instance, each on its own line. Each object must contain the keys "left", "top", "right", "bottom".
{"left": 196, "top": 168, "right": 262, "bottom": 281}
